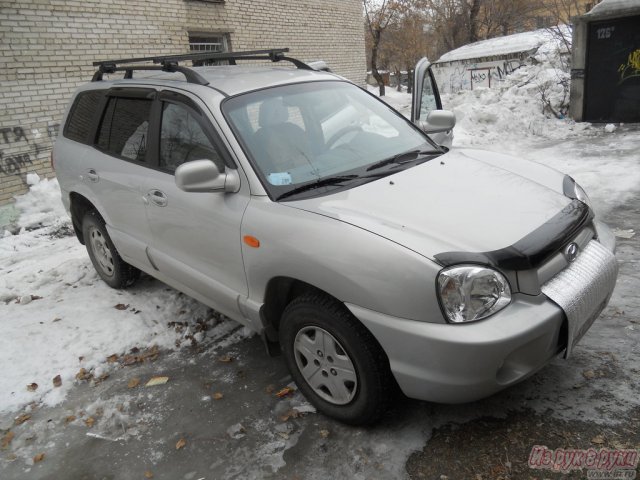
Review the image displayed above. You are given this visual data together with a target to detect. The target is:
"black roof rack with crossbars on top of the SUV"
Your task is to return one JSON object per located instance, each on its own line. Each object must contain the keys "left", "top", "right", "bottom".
{"left": 91, "top": 48, "right": 313, "bottom": 85}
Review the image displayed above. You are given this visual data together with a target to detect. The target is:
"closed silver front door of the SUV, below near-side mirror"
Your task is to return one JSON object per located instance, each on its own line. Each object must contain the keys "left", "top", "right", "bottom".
{"left": 144, "top": 90, "right": 249, "bottom": 318}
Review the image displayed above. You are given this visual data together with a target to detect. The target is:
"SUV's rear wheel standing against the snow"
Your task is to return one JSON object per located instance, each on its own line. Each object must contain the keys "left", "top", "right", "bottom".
{"left": 82, "top": 210, "right": 140, "bottom": 288}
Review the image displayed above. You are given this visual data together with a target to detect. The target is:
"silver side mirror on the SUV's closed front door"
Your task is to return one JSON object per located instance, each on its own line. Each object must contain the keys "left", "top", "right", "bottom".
{"left": 175, "top": 160, "right": 240, "bottom": 193}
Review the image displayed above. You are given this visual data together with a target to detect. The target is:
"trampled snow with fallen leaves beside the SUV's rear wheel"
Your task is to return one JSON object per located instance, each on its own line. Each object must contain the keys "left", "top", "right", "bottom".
{"left": 0, "top": 176, "right": 252, "bottom": 414}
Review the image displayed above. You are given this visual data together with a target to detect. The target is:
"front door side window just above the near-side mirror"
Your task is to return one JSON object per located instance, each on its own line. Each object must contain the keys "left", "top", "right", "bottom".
{"left": 160, "top": 103, "right": 224, "bottom": 171}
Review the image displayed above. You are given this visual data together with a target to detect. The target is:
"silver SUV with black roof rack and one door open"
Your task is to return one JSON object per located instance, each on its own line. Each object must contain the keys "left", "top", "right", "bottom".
{"left": 54, "top": 50, "right": 617, "bottom": 424}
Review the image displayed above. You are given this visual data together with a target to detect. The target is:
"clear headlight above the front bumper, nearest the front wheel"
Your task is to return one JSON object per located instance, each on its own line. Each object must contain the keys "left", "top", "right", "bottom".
{"left": 438, "top": 265, "right": 511, "bottom": 323}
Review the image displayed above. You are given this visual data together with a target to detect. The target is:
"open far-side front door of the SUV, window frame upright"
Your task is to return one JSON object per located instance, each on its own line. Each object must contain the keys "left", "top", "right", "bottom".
{"left": 411, "top": 57, "right": 453, "bottom": 148}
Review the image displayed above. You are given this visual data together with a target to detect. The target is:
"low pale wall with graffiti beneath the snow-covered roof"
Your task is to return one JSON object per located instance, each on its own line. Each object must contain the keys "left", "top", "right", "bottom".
{"left": 434, "top": 58, "right": 525, "bottom": 93}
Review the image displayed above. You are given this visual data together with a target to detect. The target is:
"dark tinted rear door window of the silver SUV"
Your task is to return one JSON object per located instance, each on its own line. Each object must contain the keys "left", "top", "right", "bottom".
{"left": 97, "top": 97, "right": 152, "bottom": 162}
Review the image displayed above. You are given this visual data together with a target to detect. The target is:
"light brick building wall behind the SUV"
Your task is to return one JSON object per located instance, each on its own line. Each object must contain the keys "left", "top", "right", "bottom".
{"left": 0, "top": 0, "right": 366, "bottom": 205}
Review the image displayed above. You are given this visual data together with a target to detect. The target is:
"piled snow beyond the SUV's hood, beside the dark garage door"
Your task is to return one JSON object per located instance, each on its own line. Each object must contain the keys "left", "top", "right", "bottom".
{"left": 368, "top": 32, "right": 640, "bottom": 218}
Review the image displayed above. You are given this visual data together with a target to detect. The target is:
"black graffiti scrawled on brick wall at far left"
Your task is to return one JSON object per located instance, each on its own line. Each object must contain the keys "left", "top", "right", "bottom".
{"left": 0, "top": 124, "right": 59, "bottom": 176}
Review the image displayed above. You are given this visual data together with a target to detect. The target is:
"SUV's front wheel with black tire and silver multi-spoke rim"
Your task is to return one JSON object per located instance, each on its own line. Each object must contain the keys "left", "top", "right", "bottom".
{"left": 280, "top": 294, "right": 394, "bottom": 425}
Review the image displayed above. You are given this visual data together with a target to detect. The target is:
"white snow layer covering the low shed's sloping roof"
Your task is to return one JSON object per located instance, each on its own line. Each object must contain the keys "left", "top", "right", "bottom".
{"left": 438, "top": 27, "right": 564, "bottom": 63}
